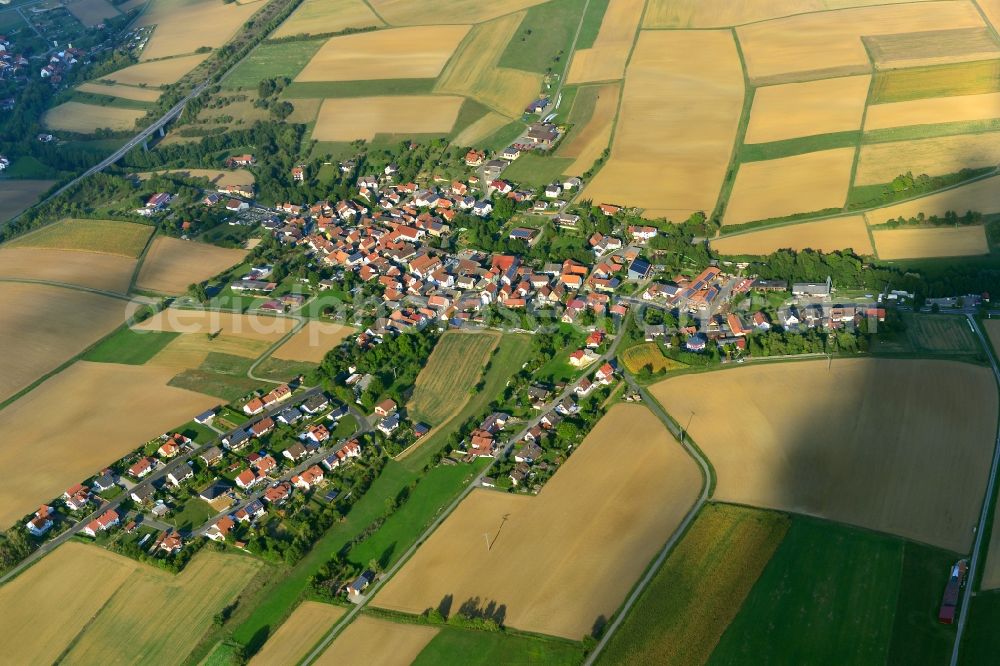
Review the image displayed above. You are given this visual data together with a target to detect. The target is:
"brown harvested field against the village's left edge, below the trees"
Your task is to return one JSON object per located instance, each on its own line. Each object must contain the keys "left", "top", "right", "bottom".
{"left": 136, "top": 236, "right": 247, "bottom": 294}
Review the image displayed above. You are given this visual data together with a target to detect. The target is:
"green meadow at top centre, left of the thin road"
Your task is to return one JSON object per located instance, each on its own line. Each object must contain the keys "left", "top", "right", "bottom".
{"left": 499, "top": 0, "right": 583, "bottom": 74}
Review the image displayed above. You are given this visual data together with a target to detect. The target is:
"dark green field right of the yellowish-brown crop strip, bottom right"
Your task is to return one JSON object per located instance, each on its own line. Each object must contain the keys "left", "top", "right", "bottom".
{"left": 709, "top": 516, "right": 904, "bottom": 664}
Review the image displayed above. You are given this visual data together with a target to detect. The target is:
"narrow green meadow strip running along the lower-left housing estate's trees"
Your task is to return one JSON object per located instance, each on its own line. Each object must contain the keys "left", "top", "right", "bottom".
{"left": 233, "top": 461, "right": 416, "bottom": 647}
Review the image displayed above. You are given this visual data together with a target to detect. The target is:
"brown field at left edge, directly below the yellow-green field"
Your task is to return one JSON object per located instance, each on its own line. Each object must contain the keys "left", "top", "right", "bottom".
{"left": 0, "top": 246, "right": 135, "bottom": 294}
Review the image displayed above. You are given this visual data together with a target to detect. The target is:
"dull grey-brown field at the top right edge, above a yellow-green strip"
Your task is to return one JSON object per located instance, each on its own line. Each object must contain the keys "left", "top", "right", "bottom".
{"left": 864, "top": 27, "right": 1000, "bottom": 70}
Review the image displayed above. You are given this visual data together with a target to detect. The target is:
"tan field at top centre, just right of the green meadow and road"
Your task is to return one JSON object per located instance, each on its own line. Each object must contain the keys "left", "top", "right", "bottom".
{"left": 566, "top": 0, "right": 646, "bottom": 83}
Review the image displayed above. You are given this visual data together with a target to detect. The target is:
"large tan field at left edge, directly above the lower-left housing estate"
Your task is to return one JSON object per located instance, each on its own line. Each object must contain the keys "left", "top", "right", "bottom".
{"left": 0, "top": 360, "right": 218, "bottom": 525}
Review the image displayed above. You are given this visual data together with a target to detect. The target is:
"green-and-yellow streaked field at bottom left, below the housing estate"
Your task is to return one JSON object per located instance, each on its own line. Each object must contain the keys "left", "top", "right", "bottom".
{"left": 61, "top": 551, "right": 261, "bottom": 664}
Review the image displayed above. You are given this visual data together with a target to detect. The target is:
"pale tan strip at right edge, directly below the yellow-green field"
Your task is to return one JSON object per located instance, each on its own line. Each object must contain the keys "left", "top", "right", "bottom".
{"left": 865, "top": 93, "right": 1000, "bottom": 130}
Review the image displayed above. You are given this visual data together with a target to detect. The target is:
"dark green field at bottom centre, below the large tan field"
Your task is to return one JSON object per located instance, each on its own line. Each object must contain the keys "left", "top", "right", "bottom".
{"left": 413, "top": 627, "right": 583, "bottom": 666}
